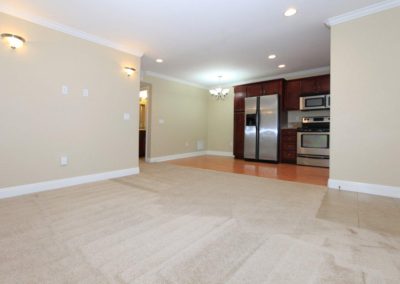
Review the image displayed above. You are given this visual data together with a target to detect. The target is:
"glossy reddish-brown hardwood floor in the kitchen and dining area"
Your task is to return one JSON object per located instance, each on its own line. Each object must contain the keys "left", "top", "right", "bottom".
{"left": 168, "top": 156, "right": 329, "bottom": 185}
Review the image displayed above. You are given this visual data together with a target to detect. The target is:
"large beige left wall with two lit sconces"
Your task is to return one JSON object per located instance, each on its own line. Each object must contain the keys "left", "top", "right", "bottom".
{"left": 0, "top": 13, "right": 140, "bottom": 188}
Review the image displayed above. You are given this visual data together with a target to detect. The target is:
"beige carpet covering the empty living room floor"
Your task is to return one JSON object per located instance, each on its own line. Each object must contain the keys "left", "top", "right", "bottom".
{"left": 0, "top": 164, "right": 400, "bottom": 284}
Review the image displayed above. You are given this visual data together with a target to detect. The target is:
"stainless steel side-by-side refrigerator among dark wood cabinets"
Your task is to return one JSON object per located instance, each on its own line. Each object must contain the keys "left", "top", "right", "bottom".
{"left": 244, "top": 95, "right": 279, "bottom": 162}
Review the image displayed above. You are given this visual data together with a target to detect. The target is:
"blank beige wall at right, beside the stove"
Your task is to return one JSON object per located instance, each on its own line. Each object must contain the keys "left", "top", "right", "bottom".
{"left": 330, "top": 8, "right": 400, "bottom": 186}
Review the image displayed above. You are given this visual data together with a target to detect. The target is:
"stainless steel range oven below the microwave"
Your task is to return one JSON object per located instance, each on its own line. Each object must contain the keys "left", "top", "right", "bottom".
{"left": 297, "top": 116, "right": 330, "bottom": 167}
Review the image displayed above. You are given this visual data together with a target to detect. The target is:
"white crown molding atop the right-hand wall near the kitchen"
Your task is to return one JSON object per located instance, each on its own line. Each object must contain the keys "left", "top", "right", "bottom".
{"left": 325, "top": 0, "right": 400, "bottom": 27}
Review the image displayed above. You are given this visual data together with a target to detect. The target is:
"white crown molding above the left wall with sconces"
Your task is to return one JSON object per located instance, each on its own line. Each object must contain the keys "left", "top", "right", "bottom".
{"left": 0, "top": 4, "right": 144, "bottom": 57}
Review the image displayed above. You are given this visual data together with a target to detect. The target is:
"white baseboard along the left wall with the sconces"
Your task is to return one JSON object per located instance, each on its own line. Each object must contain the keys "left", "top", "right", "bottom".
{"left": 0, "top": 167, "right": 139, "bottom": 199}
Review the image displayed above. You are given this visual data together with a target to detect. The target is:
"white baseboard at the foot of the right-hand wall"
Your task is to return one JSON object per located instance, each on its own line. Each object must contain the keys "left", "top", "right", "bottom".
{"left": 328, "top": 179, "right": 400, "bottom": 198}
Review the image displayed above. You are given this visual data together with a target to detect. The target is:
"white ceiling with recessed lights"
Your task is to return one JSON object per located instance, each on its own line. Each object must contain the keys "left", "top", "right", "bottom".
{"left": 0, "top": 0, "right": 388, "bottom": 87}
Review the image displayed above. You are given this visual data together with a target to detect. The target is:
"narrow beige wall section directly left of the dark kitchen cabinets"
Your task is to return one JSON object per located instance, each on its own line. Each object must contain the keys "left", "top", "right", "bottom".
{"left": 207, "top": 88, "right": 234, "bottom": 153}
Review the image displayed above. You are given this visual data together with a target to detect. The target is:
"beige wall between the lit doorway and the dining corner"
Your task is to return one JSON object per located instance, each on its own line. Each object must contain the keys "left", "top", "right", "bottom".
{"left": 143, "top": 76, "right": 208, "bottom": 158}
